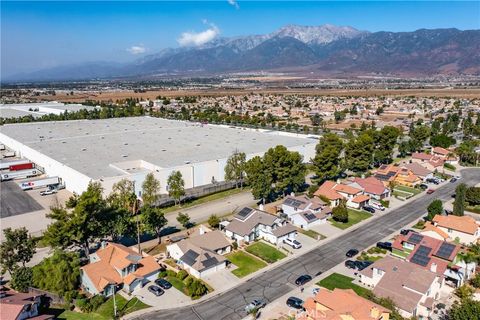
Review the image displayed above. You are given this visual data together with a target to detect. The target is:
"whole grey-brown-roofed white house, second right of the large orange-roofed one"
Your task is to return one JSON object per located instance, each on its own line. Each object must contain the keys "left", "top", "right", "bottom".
{"left": 224, "top": 207, "right": 297, "bottom": 245}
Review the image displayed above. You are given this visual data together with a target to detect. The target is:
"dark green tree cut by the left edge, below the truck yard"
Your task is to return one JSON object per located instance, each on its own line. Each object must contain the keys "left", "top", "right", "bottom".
{"left": 0, "top": 227, "right": 36, "bottom": 275}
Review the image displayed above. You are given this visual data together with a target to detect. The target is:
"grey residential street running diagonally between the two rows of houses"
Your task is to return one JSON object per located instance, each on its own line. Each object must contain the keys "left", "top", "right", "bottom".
{"left": 135, "top": 168, "right": 480, "bottom": 320}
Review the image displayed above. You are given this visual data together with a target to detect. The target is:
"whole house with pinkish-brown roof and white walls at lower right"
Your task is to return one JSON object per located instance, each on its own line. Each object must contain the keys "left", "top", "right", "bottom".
{"left": 359, "top": 256, "right": 445, "bottom": 319}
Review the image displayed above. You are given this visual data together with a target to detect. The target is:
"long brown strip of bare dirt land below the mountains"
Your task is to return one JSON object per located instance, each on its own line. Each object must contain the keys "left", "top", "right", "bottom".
{"left": 38, "top": 88, "right": 480, "bottom": 102}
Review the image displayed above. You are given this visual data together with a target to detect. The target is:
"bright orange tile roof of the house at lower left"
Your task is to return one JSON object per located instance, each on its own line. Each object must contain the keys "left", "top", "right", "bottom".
{"left": 80, "top": 242, "right": 160, "bottom": 292}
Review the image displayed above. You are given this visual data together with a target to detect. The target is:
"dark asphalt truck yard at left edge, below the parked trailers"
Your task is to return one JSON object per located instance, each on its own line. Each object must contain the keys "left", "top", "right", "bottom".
{"left": 0, "top": 181, "right": 43, "bottom": 218}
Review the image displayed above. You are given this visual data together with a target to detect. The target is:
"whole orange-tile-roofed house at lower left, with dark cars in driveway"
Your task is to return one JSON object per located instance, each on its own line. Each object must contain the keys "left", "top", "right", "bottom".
{"left": 80, "top": 242, "right": 160, "bottom": 297}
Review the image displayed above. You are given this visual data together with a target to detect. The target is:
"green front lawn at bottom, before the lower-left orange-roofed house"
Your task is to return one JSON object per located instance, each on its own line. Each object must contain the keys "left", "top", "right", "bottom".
{"left": 58, "top": 294, "right": 150, "bottom": 320}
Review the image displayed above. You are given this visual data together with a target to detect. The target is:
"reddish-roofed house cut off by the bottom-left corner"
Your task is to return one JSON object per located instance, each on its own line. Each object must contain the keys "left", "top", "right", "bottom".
{"left": 0, "top": 288, "right": 55, "bottom": 320}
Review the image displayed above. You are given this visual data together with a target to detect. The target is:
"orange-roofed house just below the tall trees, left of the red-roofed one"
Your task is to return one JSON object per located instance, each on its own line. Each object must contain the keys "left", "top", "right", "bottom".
{"left": 314, "top": 181, "right": 370, "bottom": 209}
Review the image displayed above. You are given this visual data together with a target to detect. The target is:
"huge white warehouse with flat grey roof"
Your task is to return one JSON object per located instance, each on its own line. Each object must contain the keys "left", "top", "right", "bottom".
{"left": 0, "top": 117, "right": 318, "bottom": 195}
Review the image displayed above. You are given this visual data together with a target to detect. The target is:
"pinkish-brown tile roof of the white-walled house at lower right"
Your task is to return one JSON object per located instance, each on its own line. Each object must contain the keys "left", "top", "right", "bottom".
{"left": 360, "top": 256, "right": 437, "bottom": 313}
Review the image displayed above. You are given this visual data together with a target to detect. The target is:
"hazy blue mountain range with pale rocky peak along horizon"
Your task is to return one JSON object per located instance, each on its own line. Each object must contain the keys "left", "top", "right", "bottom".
{"left": 4, "top": 24, "right": 480, "bottom": 81}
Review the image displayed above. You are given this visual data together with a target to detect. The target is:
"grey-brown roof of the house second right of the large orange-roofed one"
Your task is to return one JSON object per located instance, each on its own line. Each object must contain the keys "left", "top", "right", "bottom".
{"left": 225, "top": 207, "right": 279, "bottom": 236}
